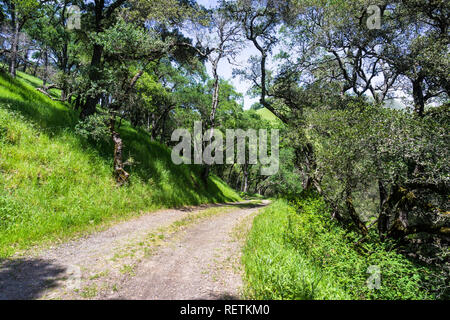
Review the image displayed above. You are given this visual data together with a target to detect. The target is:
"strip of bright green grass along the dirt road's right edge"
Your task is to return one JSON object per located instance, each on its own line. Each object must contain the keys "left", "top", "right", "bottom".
{"left": 242, "top": 200, "right": 350, "bottom": 300}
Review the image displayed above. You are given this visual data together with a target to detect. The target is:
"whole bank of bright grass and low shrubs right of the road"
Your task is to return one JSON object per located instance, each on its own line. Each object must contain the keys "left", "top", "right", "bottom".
{"left": 242, "top": 196, "right": 434, "bottom": 300}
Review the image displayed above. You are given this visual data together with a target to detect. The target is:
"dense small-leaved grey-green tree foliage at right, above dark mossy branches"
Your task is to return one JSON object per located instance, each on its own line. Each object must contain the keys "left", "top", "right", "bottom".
{"left": 305, "top": 98, "right": 449, "bottom": 220}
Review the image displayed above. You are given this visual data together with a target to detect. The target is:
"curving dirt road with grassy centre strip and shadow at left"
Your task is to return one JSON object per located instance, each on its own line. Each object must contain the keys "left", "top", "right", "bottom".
{"left": 0, "top": 200, "right": 269, "bottom": 299}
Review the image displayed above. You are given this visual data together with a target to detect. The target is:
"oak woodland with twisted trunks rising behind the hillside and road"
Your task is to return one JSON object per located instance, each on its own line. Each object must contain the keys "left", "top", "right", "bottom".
{"left": 0, "top": 0, "right": 450, "bottom": 298}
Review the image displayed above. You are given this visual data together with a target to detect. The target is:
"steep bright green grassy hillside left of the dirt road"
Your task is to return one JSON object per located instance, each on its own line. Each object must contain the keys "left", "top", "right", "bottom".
{"left": 0, "top": 73, "right": 239, "bottom": 258}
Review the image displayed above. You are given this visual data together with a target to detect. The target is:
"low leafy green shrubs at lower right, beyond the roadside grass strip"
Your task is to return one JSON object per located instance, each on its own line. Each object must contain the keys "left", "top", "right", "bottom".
{"left": 286, "top": 192, "right": 433, "bottom": 299}
